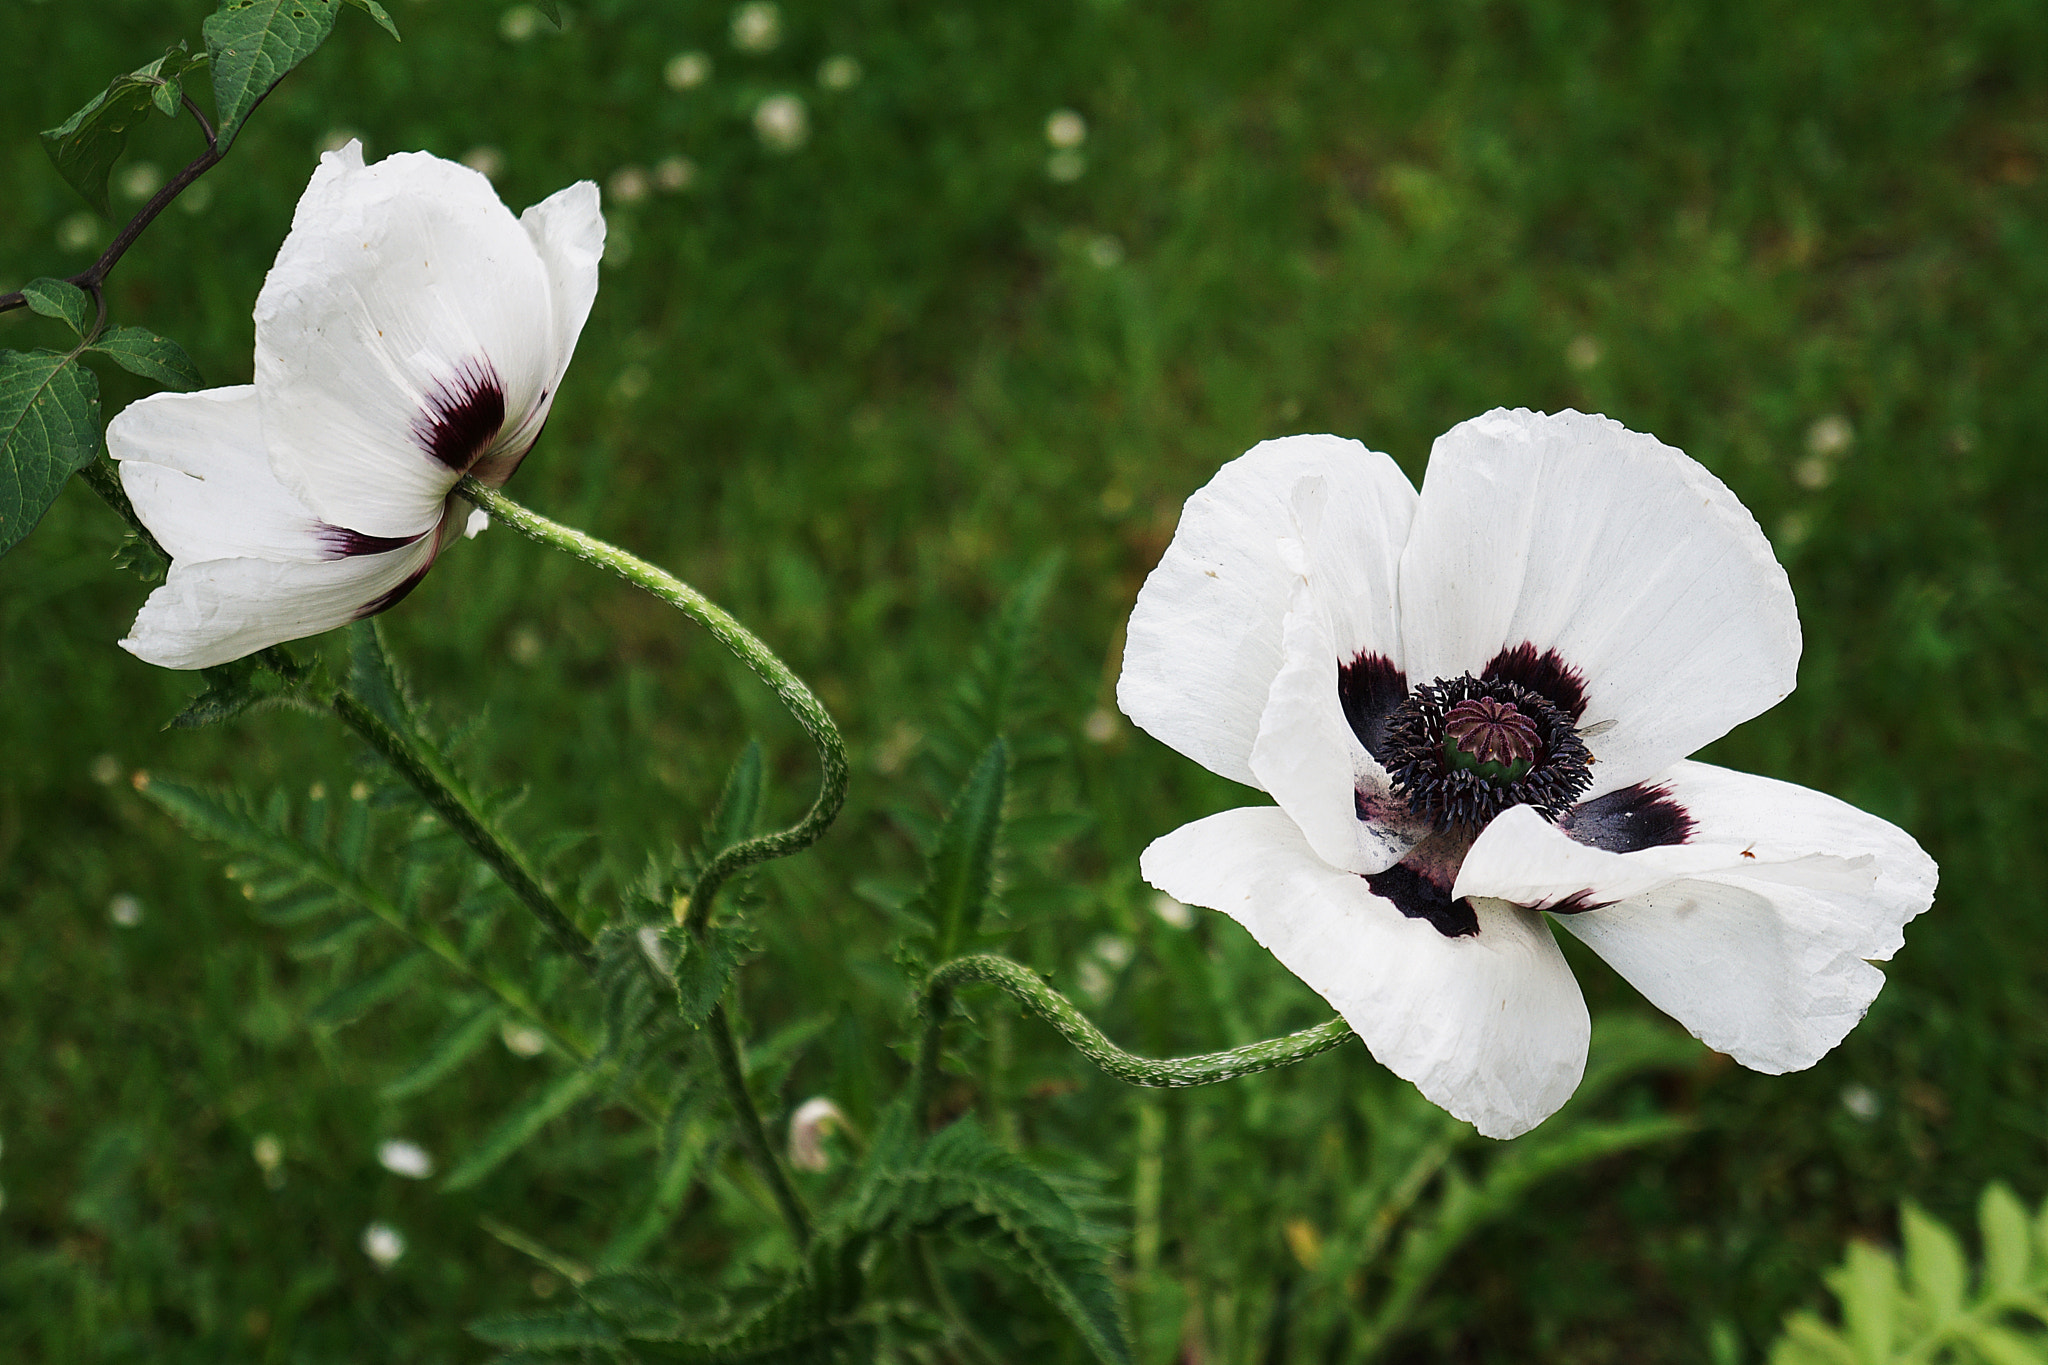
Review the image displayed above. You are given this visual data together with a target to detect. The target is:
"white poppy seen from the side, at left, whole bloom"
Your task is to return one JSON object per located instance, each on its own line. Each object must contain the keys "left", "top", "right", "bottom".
{"left": 106, "top": 143, "right": 604, "bottom": 669}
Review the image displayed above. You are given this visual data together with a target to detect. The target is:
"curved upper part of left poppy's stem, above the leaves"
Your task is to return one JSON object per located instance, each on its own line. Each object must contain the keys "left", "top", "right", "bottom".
{"left": 457, "top": 477, "right": 848, "bottom": 933}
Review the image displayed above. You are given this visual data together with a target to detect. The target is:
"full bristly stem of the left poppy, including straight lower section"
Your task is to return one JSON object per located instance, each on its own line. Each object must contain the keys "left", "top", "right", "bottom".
{"left": 457, "top": 477, "right": 827, "bottom": 1246}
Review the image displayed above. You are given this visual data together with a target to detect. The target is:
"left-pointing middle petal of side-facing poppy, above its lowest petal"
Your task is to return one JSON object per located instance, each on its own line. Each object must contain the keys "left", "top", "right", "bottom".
{"left": 106, "top": 385, "right": 336, "bottom": 563}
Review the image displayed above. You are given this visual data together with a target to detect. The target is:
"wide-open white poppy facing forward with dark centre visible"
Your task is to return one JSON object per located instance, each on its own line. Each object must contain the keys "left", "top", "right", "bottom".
{"left": 1116, "top": 411, "right": 1935, "bottom": 1138}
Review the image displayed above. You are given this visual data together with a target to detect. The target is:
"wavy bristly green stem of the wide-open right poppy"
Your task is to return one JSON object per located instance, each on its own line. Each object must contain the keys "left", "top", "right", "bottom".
{"left": 915, "top": 954, "right": 1352, "bottom": 1107}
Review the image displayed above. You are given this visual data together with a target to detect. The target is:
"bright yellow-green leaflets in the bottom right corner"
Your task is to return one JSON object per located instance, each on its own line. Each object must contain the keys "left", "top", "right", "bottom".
{"left": 1769, "top": 1183, "right": 2048, "bottom": 1365}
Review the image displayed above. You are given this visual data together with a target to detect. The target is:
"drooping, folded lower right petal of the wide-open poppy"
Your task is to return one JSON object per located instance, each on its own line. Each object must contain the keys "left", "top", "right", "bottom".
{"left": 1456, "top": 763, "right": 1935, "bottom": 1072}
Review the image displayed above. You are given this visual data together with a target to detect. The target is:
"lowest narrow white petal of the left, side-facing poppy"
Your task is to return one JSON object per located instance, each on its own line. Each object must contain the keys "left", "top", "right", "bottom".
{"left": 121, "top": 536, "right": 436, "bottom": 669}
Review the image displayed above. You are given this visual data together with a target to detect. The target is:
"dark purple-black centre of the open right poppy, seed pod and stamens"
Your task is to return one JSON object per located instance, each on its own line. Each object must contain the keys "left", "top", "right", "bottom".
{"left": 1382, "top": 673, "right": 1593, "bottom": 833}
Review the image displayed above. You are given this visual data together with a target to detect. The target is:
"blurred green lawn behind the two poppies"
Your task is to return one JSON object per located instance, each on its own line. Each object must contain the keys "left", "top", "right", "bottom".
{"left": 0, "top": 0, "right": 2048, "bottom": 1363}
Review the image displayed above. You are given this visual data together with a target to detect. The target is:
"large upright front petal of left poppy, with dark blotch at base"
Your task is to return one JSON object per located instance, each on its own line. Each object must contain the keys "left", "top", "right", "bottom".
{"left": 256, "top": 143, "right": 575, "bottom": 536}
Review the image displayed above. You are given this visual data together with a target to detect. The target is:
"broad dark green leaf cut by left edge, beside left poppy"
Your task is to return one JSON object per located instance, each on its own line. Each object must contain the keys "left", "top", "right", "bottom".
{"left": 0, "top": 350, "right": 100, "bottom": 555}
